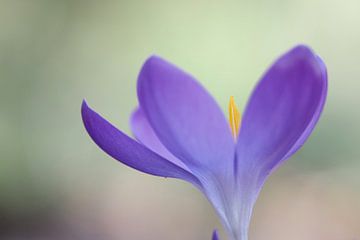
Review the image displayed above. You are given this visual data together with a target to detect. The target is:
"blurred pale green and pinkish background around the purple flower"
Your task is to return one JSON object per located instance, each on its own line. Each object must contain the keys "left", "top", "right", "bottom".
{"left": 0, "top": 0, "right": 360, "bottom": 240}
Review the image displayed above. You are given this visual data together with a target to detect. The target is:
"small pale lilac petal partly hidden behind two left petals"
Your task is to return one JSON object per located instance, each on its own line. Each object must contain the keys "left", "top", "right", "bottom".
{"left": 130, "top": 108, "right": 189, "bottom": 170}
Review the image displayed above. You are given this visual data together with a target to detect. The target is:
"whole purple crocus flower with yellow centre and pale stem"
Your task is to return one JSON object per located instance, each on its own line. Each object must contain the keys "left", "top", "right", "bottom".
{"left": 82, "top": 46, "right": 327, "bottom": 240}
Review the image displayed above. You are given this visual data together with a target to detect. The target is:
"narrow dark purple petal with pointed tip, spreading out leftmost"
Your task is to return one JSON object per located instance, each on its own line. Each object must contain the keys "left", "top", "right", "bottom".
{"left": 81, "top": 101, "right": 200, "bottom": 186}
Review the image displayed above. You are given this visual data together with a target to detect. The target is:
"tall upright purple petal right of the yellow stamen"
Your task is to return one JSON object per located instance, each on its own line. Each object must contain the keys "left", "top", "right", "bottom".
{"left": 237, "top": 46, "right": 327, "bottom": 179}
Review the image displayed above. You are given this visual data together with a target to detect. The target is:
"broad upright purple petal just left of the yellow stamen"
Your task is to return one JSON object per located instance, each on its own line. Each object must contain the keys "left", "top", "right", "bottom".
{"left": 138, "top": 57, "right": 234, "bottom": 170}
